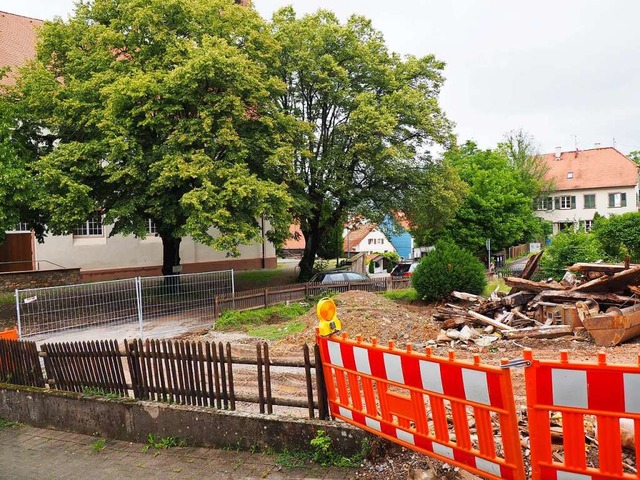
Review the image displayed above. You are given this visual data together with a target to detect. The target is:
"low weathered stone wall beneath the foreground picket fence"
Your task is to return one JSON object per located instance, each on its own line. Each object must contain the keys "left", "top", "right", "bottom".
{"left": 0, "top": 384, "right": 371, "bottom": 455}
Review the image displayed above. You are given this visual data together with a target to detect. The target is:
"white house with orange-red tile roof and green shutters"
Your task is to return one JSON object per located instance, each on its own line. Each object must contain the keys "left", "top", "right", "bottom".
{"left": 537, "top": 147, "right": 638, "bottom": 233}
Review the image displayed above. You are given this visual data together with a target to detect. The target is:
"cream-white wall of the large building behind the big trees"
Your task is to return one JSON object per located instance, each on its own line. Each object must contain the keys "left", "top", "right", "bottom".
{"left": 35, "top": 226, "right": 275, "bottom": 270}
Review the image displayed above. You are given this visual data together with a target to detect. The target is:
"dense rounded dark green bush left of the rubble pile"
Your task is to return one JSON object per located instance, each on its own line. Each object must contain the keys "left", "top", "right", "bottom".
{"left": 411, "top": 241, "right": 487, "bottom": 300}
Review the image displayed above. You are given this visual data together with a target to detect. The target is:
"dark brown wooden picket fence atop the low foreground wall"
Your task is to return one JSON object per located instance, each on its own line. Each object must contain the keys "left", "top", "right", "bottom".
{"left": 0, "top": 340, "right": 329, "bottom": 419}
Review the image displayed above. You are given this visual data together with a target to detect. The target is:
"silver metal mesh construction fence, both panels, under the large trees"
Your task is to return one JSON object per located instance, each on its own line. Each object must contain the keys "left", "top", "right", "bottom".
{"left": 16, "top": 270, "right": 234, "bottom": 338}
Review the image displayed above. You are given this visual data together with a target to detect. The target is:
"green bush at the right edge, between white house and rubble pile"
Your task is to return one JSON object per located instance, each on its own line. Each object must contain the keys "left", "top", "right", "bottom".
{"left": 592, "top": 212, "right": 640, "bottom": 263}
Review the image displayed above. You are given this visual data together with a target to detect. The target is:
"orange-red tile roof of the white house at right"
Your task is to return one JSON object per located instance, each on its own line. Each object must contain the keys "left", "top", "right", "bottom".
{"left": 542, "top": 147, "right": 638, "bottom": 191}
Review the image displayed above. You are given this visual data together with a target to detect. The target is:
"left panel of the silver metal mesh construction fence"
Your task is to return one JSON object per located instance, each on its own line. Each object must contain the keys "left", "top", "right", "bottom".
{"left": 16, "top": 278, "right": 138, "bottom": 338}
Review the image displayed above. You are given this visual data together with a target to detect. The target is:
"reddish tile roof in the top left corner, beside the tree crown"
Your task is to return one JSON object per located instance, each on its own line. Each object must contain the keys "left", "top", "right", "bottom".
{"left": 0, "top": 12, "right": 42, "bottom": 85}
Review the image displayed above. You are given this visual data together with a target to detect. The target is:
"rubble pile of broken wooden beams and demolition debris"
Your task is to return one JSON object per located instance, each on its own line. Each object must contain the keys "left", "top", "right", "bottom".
{"left": 433, "top": 254, "right": 640, "bottom": 347}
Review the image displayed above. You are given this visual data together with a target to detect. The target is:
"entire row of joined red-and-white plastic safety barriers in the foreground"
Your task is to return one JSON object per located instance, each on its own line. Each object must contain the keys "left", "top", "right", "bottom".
{"left": 317, "top": 334, "right": 640, "bottom": 480}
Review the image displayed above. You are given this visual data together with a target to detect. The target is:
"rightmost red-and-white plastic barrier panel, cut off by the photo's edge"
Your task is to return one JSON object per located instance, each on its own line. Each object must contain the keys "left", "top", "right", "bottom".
{"left": 524, "top": 350, "right": 640, "bottom": 480}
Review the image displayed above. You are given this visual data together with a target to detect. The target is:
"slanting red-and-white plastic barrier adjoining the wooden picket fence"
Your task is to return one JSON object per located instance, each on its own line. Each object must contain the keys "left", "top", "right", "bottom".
{"left": 317, "top": 334, "right": 525, "bottom": 480}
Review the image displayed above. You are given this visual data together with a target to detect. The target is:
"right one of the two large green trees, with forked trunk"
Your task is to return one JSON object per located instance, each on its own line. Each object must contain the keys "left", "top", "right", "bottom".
{"left": 271, "top": 8, "right": 453, "bottom": 279}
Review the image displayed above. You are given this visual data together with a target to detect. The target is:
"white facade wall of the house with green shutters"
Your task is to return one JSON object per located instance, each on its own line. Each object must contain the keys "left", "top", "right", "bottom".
{"left": 536, "top": 186, "right": 638, "bottom": 233}
